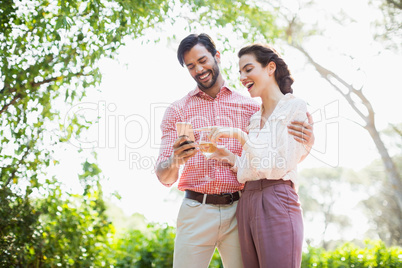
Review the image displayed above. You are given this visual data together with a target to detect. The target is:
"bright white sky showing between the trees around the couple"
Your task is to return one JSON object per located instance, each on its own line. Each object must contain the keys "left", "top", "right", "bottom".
{"left": 49, "top": 1, "right": 402, "bottom": 246}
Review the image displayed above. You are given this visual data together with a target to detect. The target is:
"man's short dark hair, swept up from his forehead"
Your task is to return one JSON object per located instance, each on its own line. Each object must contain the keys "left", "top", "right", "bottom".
{"left": 177, "top": 33, "right": 216, "bottom": 66}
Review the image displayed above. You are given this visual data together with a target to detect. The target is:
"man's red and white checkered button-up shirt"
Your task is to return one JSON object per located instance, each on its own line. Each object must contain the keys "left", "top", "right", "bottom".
{"left": 156, "top": 84, "right": 260, "bottom": 194}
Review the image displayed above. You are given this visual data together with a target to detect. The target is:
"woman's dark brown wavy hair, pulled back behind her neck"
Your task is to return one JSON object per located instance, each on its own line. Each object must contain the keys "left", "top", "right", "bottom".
{"left": 237, "top": 44, "right": 294, "bottom": 94}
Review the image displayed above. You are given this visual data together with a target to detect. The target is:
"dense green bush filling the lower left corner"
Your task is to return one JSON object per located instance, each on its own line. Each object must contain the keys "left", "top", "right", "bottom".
{"left": 0, "top": 162, "right": 114, "bottom": 267}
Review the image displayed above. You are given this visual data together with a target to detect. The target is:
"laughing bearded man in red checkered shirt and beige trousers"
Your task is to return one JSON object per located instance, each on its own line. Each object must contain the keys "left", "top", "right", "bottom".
{"left": 156, "top": 34, "right": 314, "bottom": 268}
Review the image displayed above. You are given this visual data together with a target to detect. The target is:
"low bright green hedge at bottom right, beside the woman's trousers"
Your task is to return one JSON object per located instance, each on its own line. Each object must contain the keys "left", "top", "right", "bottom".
{"left": 301, "top": 240, "right": 402, "bottom": 268}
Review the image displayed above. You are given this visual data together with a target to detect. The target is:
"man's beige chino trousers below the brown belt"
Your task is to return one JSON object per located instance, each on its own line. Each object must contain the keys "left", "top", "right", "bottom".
{"left": 173, "top": 198, "right": 243, "bottom": 268}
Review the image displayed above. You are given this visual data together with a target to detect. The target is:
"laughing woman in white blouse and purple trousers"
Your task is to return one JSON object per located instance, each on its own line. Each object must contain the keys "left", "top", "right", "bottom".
{"left": 209, "top": 44, "right": 308, "bottom": 268}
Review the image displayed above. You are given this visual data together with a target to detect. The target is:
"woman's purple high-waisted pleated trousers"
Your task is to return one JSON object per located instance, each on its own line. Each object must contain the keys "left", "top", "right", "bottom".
{"left": 236, "top": 179, "right": 303, "bottom": 268}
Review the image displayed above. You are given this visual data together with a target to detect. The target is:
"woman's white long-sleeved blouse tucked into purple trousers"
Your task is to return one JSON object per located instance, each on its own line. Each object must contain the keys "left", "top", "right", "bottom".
{"left": 236, "top": 93, "right": 308, "bottom": 185}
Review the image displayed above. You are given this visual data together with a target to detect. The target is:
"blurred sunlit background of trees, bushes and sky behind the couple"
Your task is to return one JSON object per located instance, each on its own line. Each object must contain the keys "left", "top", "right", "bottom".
{"left": 0, "top": 0, "right": 402, "bottom": 267}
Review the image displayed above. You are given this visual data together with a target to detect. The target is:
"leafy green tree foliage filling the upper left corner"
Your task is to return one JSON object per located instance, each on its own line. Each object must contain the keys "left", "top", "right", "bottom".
{"left": 0, "top": 0, "right": 168, "bottom": 195}
